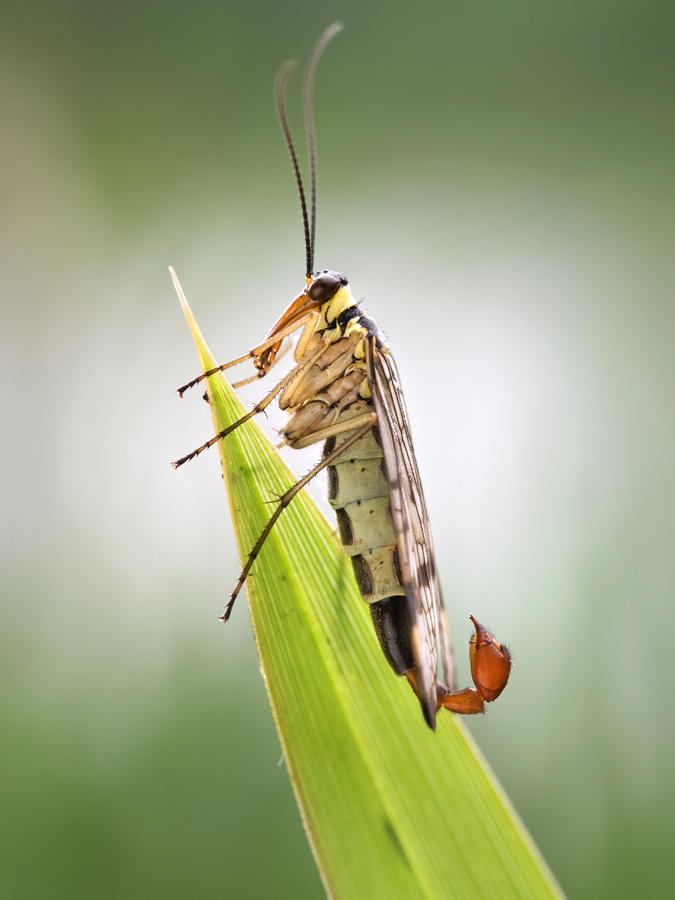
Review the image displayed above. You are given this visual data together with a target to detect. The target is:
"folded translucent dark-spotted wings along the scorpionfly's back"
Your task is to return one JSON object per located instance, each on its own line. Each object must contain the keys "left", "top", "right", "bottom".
{"left": 368, "top": 339, "right": 454, "bottom": 728}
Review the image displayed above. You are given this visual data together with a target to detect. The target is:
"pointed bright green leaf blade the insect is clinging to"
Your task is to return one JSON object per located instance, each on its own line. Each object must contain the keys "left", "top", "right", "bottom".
{"left": 174, "top": 276, "right": 563, "bottom": 900}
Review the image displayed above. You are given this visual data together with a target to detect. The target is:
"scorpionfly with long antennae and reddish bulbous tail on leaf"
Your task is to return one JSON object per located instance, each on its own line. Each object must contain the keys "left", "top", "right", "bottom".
{"left": 171, "top": 23, "right": 511, "bottom": 728}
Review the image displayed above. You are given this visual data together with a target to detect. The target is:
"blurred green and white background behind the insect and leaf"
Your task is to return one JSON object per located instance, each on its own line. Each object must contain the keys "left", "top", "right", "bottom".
{"left": 0, "top": 0, "right": 675, "bottom": 900}
